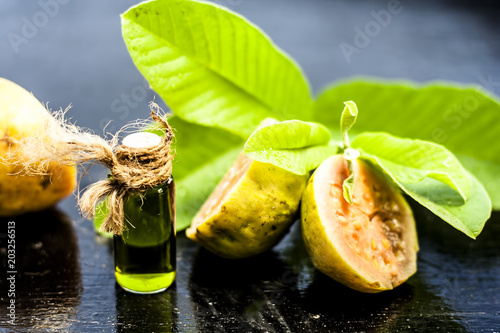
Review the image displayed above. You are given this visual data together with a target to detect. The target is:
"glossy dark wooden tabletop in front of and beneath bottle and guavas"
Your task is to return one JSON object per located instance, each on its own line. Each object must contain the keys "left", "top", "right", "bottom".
{"left": 0, "top": 202, "right": 500, "bottom": 332}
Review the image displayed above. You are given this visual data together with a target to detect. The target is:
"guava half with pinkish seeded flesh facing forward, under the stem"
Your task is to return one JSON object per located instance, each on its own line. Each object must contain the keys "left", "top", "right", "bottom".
{"left": 301, "top": 155, "right": 418, "bottom": 293}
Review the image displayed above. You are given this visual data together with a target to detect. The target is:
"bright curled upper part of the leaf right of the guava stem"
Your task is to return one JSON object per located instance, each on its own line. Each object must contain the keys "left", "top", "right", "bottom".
{"left": 352, "top": 133, "right": 471, "bottom": 200}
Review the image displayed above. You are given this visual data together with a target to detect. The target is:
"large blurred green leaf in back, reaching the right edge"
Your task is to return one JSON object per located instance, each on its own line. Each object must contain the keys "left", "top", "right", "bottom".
{"left": 313, "top": 78, "right": 500, "bottom": 209}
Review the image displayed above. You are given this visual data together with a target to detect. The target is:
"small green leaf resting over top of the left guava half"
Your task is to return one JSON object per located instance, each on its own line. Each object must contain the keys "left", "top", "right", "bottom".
{"left": 245, "top": 120, "right": 338, "bottom": 175}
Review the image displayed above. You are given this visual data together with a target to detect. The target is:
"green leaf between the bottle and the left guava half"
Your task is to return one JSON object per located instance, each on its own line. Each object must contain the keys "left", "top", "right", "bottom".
{"left": 150, "top": 116, "right": 244, "bottom": 231}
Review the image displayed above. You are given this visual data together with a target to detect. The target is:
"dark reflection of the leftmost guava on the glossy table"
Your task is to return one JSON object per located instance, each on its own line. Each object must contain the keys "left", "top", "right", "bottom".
{"left": 0, "top": 209, "right": 82, "bottom": 332}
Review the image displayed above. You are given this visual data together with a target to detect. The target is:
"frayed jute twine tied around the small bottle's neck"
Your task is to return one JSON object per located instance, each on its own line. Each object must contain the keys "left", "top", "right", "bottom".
{"left": 11, "top": 102, "right": 174, "bottom": 235}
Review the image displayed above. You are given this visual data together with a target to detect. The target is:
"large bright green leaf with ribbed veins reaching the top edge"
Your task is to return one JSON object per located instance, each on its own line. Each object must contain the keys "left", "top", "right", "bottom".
{"left": 122, "top": 0, "right": 312, "bottom": 139}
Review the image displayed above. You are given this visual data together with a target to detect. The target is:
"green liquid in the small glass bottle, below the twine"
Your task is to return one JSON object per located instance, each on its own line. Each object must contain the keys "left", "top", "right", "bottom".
{"left": 113, "top": 177, "right": 176, "bottom": 294}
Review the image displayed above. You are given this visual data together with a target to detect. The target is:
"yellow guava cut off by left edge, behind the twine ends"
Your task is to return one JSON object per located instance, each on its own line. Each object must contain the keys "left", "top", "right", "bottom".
{"left": 0, "top": 78, "right": 76, "bottom": 216}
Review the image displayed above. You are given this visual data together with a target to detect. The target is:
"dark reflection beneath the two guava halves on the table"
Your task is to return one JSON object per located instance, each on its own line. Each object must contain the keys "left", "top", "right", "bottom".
{"left": 188, "top": 219, "right": 463, "bottom": 332}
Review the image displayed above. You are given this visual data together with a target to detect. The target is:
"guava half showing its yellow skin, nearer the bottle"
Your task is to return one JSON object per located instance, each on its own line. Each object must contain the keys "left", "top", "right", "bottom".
{"left": 186, "top": 153, "right": 308, "bottom": 259}
